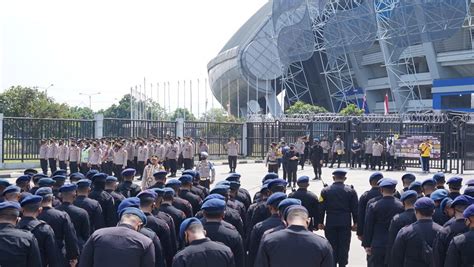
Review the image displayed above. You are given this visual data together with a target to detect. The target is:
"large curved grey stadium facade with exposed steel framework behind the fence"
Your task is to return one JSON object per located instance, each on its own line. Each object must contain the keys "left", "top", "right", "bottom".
{"left": 208, "top": 0, "right": 474, "bottom": 116}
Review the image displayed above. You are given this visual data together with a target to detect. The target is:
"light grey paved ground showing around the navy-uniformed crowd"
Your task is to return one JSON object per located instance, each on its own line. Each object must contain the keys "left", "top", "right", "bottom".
{"left": 1, "top": 163, "right": 474, "bottom": 267}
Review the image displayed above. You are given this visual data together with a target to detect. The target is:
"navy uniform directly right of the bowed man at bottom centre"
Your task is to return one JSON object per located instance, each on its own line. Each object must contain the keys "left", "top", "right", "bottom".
{"left": 203, "top": 222, "right": 244, "bottom": 267}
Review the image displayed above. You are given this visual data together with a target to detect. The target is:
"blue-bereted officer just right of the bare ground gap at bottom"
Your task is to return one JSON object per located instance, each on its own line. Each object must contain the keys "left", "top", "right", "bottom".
{"left": 362, "top": 178, "right": 404, "bottom": 267}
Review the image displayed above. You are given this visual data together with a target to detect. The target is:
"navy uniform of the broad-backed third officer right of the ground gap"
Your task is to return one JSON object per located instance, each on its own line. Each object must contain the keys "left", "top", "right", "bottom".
{"left": 391, "top": 219, "right": 442, "bottom": 267}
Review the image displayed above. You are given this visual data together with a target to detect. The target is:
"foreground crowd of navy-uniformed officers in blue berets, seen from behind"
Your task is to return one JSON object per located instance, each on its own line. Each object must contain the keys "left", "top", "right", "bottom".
{"left": 0, "top": 162, "right": 474, "bottom": 267}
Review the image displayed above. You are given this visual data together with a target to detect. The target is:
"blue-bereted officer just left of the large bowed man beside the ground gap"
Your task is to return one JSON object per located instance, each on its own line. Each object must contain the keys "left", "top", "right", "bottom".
{"left": 248, "top": 192, "right": 286, "bottom": 266}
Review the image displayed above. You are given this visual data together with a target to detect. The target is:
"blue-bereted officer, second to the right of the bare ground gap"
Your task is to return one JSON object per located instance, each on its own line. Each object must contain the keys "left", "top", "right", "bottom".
{"left": 385, "top": 190, "right": 418, "bottom": 264}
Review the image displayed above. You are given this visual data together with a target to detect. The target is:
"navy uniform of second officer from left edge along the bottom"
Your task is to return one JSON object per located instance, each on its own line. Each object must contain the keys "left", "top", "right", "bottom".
{"left": 17, "top": 217, "right": 62, "bottom": 267}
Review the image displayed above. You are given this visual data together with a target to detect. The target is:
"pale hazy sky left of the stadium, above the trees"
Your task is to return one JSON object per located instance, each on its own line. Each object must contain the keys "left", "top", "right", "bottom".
{"left": 0, "top": 0, "right": 268, "bottom": 114}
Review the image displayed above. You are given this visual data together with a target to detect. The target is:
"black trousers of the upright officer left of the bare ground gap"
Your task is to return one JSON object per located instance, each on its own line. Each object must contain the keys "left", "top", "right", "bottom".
{"left": 324, "top": 226, "right": 351, "bottom": 265}
